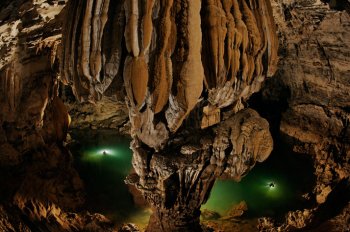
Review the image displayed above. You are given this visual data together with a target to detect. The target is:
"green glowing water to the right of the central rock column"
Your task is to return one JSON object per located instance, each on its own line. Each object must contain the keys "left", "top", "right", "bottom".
{"left": 202, "top": 149, "right": 315, "bottom": 217}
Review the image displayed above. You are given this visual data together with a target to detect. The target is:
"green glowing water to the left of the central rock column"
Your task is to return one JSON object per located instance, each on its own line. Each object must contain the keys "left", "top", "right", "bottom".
{"left": 70, "top": 130, "right": 150, "bottom": 228}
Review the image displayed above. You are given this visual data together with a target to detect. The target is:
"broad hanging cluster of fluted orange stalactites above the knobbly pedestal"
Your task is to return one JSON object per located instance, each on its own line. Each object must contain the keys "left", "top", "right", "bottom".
{"left": 61, "top": 0, "right": 278, "bottom": 150}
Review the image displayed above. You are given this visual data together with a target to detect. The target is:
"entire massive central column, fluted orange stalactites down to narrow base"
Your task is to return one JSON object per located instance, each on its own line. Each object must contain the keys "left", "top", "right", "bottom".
{"left": 61, "top": 0, "right": 278, "bottom": 231}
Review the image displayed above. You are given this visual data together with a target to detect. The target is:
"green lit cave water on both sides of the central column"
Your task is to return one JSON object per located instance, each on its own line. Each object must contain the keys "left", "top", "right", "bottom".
{"left": 70, "top": 130, "right": 314, "bottom": 228}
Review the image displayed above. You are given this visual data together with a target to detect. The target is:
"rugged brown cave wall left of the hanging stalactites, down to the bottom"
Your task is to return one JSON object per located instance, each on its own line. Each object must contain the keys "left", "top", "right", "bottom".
{"left": 0, "top": 0, "right": 111, "bottom": 231}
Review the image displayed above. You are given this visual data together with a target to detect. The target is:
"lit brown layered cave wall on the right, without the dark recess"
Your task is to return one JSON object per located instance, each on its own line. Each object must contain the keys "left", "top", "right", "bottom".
{"left": 274, "top": 2, "right": 350, "bottom": 203}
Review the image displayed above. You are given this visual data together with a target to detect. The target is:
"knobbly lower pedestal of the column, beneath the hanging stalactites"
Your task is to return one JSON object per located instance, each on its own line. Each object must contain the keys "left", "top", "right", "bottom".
{"left": 126, "top": 109, "right": 273, "bottom": 232}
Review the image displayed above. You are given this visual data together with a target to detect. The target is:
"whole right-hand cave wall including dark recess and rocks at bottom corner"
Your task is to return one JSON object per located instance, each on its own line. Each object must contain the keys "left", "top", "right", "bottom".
{"left": 254, "top": 0, "right": 350, "bottom": 231}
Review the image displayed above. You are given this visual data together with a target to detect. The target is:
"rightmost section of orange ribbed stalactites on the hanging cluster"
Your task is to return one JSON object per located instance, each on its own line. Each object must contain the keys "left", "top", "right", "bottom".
{"left": 202, "top": 1, "right": 278, "bottom": 111}
